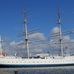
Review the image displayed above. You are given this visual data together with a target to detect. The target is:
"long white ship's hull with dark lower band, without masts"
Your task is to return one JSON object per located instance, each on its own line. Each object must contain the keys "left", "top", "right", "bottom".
{"left": 0, "top": 56, "right": 74, "bottom": 68}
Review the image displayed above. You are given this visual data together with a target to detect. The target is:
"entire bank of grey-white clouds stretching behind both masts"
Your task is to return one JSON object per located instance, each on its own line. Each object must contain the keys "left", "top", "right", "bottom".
{"left": 10, "top": 27, "right": 74, "bottom": 54}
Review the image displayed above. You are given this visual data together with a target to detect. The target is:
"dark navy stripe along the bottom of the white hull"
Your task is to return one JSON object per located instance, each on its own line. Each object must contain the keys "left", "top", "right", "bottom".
{"left": 0, "top": 64, "right": 74, "bottom": 68}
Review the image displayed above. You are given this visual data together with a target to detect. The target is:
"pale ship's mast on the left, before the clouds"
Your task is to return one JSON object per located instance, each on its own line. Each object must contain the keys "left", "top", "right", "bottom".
{"left": 24, "top": 17, "right": 29, "bottom": 59}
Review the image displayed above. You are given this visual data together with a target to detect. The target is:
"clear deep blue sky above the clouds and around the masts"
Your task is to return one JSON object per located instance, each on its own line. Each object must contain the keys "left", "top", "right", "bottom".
{"left": 0, "top": 0, "right": 74, "bottom": 40}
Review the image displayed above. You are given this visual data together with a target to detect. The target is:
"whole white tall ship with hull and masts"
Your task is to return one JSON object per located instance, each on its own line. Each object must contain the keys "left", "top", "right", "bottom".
{"left": 0, "top": 9, "right": 74, "bottom": 69}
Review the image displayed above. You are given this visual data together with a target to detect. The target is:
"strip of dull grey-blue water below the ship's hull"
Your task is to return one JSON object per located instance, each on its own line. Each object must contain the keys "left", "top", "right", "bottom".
{"left": 0, "top": 69, "right": 74, "bottom": 74}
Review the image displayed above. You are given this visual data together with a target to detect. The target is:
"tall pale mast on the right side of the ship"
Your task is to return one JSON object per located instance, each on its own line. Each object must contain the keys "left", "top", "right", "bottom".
{"left": 57, "top": 7, "right": 63, "bottom": 57}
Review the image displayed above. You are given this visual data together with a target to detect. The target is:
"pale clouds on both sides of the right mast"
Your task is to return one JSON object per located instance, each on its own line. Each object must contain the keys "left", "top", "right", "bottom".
{"left": 49, "top": 27, "right": 74, "bottom": 54}
